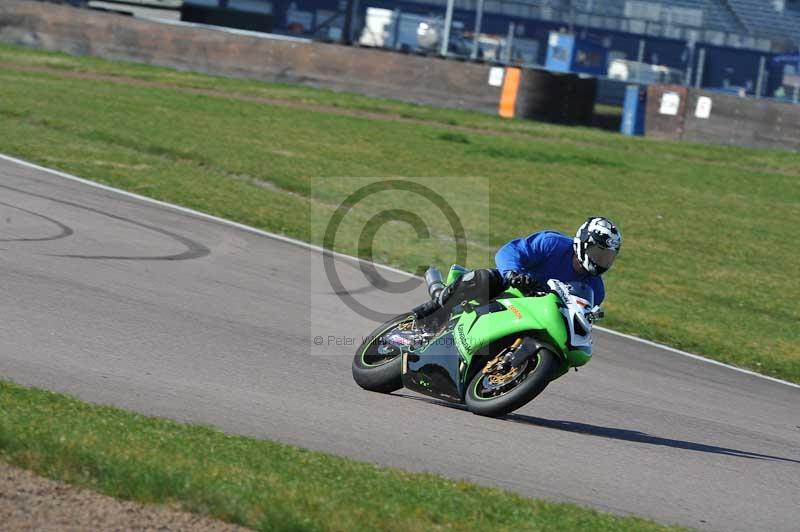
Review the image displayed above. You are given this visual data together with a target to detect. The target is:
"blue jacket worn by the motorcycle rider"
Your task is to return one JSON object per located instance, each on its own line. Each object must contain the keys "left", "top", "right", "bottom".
{"left": 495, "top": 231, "right": 606, "bottom": 305}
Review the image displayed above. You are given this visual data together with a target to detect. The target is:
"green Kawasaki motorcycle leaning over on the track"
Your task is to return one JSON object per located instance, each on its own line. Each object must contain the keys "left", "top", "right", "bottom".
{"left": 353, "top": 265, "right": 603, "bottom": 417}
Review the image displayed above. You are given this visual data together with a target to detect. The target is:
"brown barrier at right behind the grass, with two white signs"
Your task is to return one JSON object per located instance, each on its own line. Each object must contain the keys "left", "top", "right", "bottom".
{"left": 645, "top": 85, "right": 800, "bottom": 150}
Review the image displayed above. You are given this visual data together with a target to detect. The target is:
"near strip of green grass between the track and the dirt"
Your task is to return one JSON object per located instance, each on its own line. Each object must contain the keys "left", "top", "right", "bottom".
{"left": 0, "top": 381, "right": 678, "bottom": 532}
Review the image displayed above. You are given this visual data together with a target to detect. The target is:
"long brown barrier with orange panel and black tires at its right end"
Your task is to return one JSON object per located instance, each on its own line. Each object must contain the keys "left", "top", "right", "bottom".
{"left": 0, "top": 0, "right": 594, "bottom": 124}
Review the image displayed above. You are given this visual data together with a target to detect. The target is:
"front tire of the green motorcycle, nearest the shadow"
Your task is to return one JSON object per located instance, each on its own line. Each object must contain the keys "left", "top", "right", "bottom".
{"left": 465, "top": 349, "right": 559, "bottom": 417}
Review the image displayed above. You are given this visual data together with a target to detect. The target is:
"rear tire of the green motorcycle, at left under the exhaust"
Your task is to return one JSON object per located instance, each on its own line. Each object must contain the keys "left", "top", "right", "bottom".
{"left": 353, "top": 314, "right": 413, "bottom": 393}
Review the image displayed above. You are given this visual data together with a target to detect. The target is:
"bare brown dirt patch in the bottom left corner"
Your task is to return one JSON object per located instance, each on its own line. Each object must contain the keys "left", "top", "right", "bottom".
{"left": 0, "top": 462, "right": 248, "bottom": 532}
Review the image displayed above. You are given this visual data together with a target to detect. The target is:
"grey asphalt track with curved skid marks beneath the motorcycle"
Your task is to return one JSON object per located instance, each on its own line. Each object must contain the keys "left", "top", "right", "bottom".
{"left": 0, "top": 160, "right": 800, "bottom": 531}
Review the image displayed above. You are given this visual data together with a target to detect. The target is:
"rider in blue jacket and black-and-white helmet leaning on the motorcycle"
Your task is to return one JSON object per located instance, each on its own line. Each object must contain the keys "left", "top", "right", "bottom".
{"left": 412, "top": 216, "right": 622, "bottom": 322}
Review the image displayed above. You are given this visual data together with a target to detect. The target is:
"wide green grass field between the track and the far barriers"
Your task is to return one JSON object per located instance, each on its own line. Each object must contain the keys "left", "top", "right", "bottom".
{"left": 0, "top": 42, "right": 800, "bottom": 382}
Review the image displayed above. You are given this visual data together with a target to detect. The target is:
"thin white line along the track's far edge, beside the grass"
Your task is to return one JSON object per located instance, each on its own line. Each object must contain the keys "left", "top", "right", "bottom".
{"left": 0, "top": 153, "right": 800, "bottom": 388}
